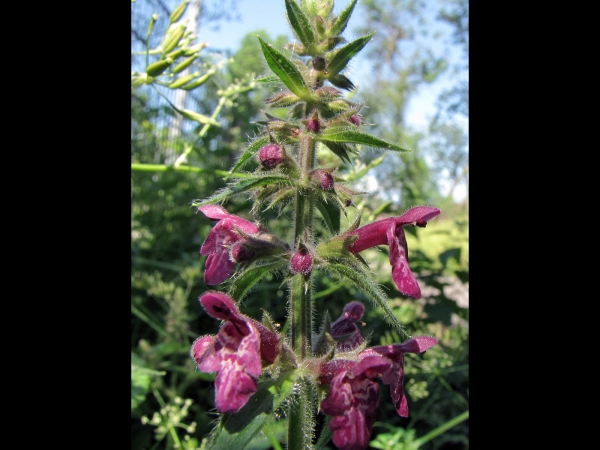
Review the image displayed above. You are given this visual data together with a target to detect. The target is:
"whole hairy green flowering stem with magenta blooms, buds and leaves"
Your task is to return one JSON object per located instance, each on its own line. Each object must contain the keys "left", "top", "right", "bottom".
{"left": 191, "top": 0, "right": 440, "bottom": 450}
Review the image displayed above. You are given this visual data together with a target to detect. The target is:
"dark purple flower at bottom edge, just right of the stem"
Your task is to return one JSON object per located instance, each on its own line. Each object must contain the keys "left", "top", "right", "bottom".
{"left": 320, "top": 355, "right": 391, "bottom": 450}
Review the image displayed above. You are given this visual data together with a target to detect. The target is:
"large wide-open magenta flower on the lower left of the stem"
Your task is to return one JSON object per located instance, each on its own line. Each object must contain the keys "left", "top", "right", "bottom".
{"left": 190, "top": 291, "right": 279, "bottom": 413}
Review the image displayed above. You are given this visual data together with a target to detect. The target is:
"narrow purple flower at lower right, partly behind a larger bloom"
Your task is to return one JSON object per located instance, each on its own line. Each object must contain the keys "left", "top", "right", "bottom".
{"left": 361, "top": 336, "right": 438, "bottom": 417}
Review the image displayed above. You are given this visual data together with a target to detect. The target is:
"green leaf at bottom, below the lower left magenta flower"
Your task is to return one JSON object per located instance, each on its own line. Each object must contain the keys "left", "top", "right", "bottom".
{"left": 207, "top": 370, "right": 298, "bottom": 450}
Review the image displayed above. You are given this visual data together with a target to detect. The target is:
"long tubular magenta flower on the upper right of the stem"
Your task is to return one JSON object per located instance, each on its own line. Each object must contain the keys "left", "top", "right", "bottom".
{"left": 348, "top": 206, "right": 440, "bottom": 299}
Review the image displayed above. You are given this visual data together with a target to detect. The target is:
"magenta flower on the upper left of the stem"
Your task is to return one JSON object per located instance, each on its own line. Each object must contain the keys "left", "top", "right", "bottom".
{"left": 198, "top": 205, "right": 259, "bottom": 285}
